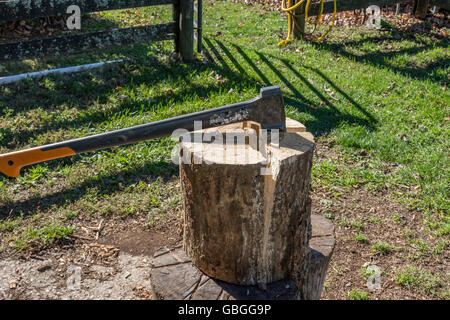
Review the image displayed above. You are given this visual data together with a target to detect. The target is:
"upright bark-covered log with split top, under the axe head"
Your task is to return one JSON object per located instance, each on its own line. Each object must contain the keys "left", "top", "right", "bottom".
{"left": 180, "top": 117, "right": 314, "bottom": 285}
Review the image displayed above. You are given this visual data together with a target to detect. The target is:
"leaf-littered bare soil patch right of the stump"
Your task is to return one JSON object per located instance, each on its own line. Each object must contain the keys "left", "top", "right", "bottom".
{"left": 312, "top": 144, "right": 449, "bottom": 299}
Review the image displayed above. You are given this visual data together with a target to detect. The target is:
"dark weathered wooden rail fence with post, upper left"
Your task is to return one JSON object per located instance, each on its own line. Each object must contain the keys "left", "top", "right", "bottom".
{"left": 0, "top": 0, "right": 202, "bottom": 62}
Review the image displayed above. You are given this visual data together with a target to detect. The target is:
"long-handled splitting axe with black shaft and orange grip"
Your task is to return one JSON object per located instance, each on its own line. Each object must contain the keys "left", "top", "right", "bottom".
{"left": 0, "top": 86, "right": 286, "bottom": 177}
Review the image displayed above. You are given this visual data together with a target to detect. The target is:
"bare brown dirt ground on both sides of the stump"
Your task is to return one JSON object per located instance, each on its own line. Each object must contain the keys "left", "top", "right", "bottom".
{"left": 0, "top": 145, "right": 449, "bottom": 299}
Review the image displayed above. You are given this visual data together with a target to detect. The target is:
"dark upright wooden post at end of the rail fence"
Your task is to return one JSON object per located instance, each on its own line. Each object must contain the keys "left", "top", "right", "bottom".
{"left": 178, "top": 0, "right": 194, "bottom": 62}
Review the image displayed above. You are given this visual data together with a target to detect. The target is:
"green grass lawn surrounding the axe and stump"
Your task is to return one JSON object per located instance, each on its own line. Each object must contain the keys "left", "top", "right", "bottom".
{"left": 0, "top": 1, "right": 450, "bottom": 299}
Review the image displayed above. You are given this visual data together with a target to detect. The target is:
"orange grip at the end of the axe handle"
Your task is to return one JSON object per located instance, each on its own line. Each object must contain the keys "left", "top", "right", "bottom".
{"left": 0, "top": 147, "right": 76, "bottom": 178}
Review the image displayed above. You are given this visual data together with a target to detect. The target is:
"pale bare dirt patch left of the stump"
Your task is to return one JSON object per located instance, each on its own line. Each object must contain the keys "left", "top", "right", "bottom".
{"left": 0, "top": 211, "right": 181, "bottom": 300}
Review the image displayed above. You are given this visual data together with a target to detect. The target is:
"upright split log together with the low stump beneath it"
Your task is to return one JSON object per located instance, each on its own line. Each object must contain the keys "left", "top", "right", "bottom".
{"left": 151, "top": 119, "right": 334, "bottom": 300}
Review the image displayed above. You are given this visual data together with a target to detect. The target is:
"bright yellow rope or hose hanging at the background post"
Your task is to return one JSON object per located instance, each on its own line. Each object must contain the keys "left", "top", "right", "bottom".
{"left": 278, "top": 0, "right": 337, "bottom": 46}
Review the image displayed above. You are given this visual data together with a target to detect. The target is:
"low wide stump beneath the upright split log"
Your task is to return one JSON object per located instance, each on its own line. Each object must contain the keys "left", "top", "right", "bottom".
{"left": 151, "top": 215, "right": 335, "bottom": 300}
